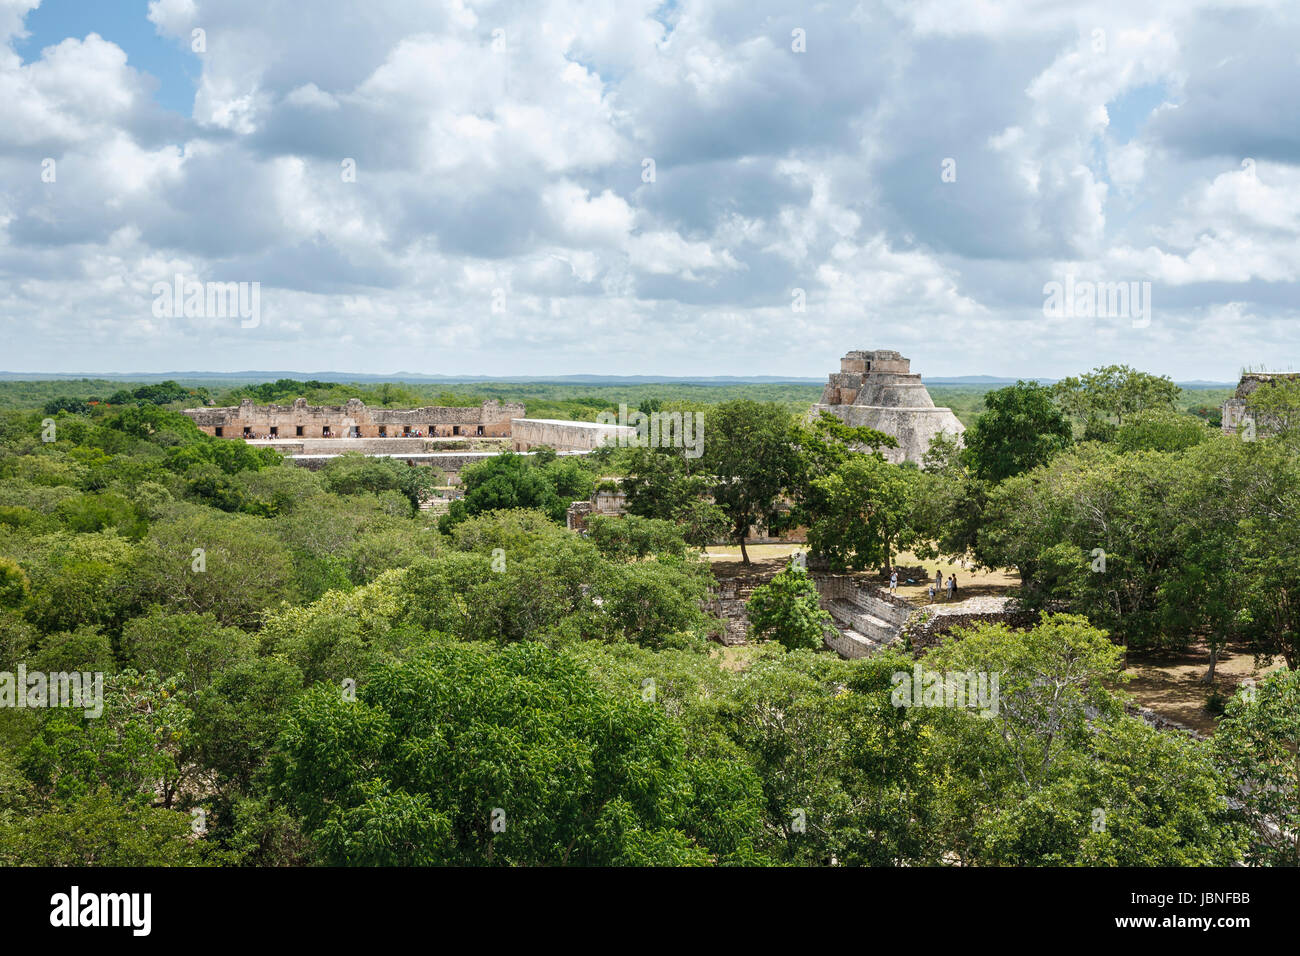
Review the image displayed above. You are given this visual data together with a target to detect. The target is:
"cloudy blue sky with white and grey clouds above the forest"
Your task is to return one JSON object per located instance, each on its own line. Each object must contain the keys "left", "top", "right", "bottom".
{"left": 0, "top": 0, "right": 1300, "bottom": 381}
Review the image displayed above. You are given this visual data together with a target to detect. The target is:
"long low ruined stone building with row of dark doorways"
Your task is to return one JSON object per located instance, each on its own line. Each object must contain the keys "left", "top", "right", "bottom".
{"left": 185, "top": 398, "right": 524, "bottom": 440}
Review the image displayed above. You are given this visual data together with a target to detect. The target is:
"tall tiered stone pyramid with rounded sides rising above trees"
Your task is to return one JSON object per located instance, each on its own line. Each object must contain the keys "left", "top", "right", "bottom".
{"left": 811, "top": 349, "right": 966, "bottom": 464}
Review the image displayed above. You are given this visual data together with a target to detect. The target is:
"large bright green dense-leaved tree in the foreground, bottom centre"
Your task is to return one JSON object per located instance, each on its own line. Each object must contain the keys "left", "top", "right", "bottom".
{"left": 273, "top": 644, "right": 759, "bottom": 865}
